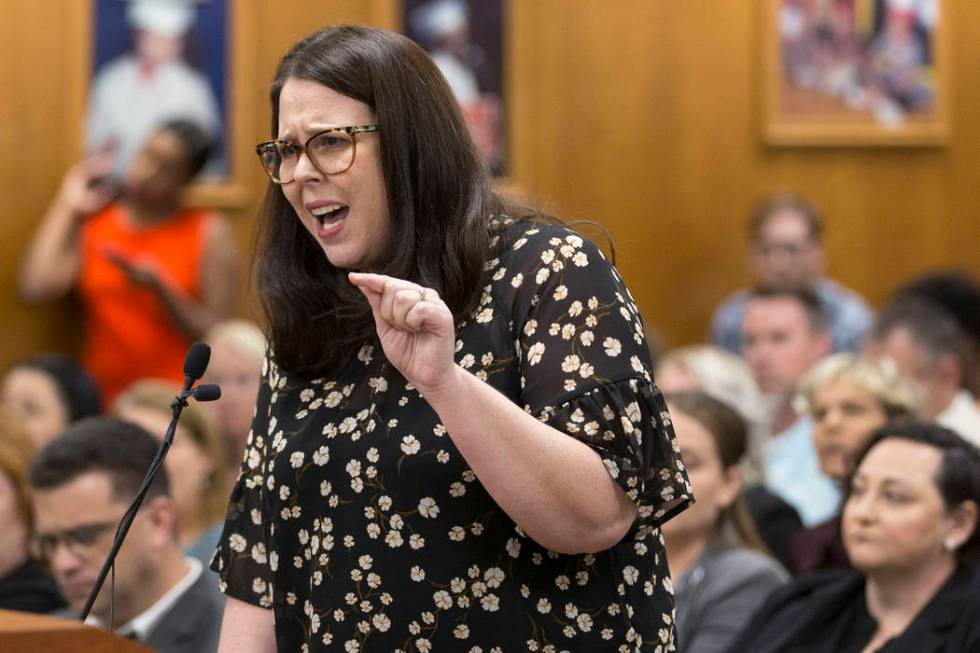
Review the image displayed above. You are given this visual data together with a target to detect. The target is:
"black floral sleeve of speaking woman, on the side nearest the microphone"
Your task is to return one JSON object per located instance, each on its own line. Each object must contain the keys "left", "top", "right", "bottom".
{"left": 211, "top": 354, "right": 279, "bottom": 608}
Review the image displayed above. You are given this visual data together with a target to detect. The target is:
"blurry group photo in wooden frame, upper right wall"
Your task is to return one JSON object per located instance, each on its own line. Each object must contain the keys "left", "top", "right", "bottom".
{"left": 761, "top": 0, "right": 950, "bottom": 145}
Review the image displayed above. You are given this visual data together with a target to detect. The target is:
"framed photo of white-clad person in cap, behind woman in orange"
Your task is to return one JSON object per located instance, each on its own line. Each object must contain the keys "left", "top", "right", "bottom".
{"left": 83, "top": 0, "right": 252, "bottom": 207}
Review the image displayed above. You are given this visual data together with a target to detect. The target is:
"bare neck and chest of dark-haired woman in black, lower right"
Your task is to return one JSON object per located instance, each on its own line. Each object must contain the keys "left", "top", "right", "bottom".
{"left": 865, "top": 556, "right": 956, "bottom": 650}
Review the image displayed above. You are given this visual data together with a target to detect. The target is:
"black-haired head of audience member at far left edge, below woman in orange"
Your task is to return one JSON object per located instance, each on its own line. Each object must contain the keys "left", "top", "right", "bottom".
{"left": 0, "top": 354, "right": 100, "bottom": 447}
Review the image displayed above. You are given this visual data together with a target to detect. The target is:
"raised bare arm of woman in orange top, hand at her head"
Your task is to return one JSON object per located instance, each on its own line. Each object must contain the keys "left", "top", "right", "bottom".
{"left": 17, "top": 155, "right": 115, "bottom": 303}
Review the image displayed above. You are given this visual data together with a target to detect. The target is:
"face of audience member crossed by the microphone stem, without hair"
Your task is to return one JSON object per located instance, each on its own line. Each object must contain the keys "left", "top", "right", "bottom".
{"left": 118, "top": 406, "right": 214, "bottom": 528}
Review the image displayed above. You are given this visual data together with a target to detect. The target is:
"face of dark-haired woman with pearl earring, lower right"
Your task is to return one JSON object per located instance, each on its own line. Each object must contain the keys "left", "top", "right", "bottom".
{"left": 842, "top": 438, "right": 972, "bottom": 574}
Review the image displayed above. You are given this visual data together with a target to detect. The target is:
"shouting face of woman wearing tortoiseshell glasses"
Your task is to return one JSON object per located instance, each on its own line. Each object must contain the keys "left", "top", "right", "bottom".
{"left": 278, "top": 79, "right": 391, "bottom": 271}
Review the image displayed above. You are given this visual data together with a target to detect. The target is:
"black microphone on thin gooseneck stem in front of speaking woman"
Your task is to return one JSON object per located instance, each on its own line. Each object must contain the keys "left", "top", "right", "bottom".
{"left": 79, "top": 342, "right": 221, "bottom": 630}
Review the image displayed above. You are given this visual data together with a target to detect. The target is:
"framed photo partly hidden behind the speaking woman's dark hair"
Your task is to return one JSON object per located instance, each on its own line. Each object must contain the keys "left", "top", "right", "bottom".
{"left": 402, "top": 0, "right": 507, "bottom": 177}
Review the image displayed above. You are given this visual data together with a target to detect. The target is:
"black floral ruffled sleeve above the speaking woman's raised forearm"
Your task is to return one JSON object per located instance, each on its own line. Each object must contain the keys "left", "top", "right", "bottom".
{"left": 501, "top": 224, "right": 693, "bottom": 527}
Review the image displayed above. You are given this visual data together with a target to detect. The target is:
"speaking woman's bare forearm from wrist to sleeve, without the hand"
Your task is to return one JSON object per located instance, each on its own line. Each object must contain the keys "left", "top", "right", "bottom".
{"left": 420, "top": 365, "right": 637, "bottom": 553}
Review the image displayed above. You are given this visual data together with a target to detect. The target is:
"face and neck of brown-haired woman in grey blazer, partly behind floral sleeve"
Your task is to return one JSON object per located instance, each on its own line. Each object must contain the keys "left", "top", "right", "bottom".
{"left": 663, "top": 410, "right": 741, "bottom": 540}
